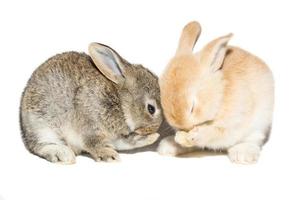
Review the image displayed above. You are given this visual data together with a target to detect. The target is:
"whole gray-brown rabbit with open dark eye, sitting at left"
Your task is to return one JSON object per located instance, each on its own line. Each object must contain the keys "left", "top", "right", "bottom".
{"left": 20, "top": 43, "right": 162, "bottom": 164}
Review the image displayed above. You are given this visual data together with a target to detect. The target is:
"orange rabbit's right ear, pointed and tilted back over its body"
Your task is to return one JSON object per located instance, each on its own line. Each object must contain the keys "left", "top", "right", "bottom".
{"left": 200, "top": 33, "right": 233, "bottom": 72}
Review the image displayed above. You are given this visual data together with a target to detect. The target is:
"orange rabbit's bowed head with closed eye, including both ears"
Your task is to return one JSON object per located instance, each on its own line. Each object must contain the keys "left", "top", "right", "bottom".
{"left": 160, "top": 21, "right": 232, "bottom": 130}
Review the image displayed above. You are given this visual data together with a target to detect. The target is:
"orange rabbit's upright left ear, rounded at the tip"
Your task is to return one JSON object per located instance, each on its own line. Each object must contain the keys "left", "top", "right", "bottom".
{"left": 176, "top": 21, "right": 201, "bottom": 55}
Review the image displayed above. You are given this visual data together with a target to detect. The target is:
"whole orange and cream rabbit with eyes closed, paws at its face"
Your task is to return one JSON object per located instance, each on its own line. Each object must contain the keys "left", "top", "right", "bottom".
{"left": 158, "top": 22, "right": 274, "bottom": 163}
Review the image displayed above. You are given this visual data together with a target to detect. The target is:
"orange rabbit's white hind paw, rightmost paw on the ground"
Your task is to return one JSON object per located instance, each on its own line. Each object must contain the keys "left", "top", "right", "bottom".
{"left": 228, "top": 143, "right": 260, "bottom": 164}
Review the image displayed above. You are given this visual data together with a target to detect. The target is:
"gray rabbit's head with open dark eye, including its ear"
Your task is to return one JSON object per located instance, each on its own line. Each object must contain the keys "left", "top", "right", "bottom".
{"left": 89, "top": 43, "right": 162, "bottom": 135}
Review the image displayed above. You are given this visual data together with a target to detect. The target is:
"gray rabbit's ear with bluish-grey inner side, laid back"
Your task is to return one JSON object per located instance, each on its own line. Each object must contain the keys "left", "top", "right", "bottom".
{"left": 89, "top": 43, "right": 124, "bottom": 84}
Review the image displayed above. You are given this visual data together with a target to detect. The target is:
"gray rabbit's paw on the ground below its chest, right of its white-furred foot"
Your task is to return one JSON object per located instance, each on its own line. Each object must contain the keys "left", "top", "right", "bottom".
{"left": 92, "top": 147, "right": 120, "bottom": 162}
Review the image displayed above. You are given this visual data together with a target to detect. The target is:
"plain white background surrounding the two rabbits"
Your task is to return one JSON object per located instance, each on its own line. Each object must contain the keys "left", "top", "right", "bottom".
{"left": 0, "top": 0, "right": 300, "bottom": 200}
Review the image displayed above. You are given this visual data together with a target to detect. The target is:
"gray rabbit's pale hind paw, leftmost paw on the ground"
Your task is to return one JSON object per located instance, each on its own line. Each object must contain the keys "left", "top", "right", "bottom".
{"left": 40, "top": 144, "right": 76, "bottom": 164}
